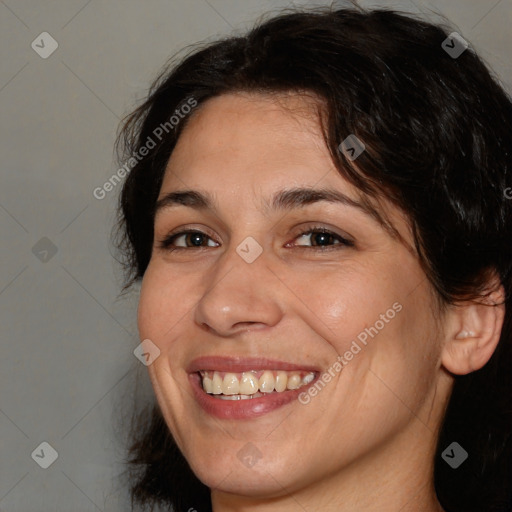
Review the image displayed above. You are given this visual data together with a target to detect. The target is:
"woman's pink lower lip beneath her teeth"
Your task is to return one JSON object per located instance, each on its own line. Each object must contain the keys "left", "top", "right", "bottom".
{"left": 189, "top": 373, "right": 316, "bottom": 420}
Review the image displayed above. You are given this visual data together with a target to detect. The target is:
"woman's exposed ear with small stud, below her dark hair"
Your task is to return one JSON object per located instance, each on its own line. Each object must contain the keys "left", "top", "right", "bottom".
{"left": 441, "top": 278, "right": 505, "bottom": 375}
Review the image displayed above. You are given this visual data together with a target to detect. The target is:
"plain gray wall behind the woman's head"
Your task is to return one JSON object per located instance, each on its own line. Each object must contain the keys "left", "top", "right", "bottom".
{"left": 0, "top": 0, "right": 512, "bottom": 512}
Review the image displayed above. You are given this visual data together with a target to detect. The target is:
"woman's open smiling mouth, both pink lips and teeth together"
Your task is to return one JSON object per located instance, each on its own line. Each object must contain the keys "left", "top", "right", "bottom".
{"left": 188, "top": 357, "right": 320, "bottom": 419}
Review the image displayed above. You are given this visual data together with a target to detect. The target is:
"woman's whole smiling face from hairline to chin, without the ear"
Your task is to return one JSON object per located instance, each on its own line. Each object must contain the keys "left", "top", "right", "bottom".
{"left": 138, "top": 94, "right": 446, "bottom": 504}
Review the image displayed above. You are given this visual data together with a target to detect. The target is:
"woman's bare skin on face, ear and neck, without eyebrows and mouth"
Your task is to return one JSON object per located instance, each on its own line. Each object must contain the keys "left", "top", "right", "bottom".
{"left": 138, "top": 93, "right": 503, "bottom": 512}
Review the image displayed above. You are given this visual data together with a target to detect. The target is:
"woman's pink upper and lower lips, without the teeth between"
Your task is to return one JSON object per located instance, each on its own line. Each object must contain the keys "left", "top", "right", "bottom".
{"left": 187, "top": 356, "right": 320, "bottom": 420}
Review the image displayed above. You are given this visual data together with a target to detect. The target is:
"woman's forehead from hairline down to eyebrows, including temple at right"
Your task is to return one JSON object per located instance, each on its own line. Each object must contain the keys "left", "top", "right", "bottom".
{"left": 159, "top": 93, "right": 410, "bottom": 250}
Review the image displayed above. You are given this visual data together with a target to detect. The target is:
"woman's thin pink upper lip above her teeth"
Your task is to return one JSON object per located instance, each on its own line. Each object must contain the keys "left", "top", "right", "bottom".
{"left": 187, "top": 356, "right": 319, "bottom": 373}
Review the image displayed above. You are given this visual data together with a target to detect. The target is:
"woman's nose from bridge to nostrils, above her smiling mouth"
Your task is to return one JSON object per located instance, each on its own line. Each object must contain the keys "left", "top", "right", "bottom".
{"left": 194, "top": 248, "right": 283, "bottom": 337}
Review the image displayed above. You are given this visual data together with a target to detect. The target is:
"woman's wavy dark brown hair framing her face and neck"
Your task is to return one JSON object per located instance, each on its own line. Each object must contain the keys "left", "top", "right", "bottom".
{"left": 117, "top": 8, "right": 512, "bottom": 512}
